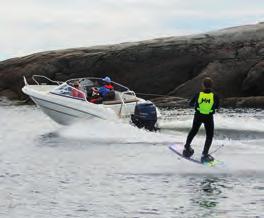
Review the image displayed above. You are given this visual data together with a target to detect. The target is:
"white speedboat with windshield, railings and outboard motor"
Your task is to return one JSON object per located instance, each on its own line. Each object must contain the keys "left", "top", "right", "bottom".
{"left": 22, "top": 75, "right": 160, "bottom": 130}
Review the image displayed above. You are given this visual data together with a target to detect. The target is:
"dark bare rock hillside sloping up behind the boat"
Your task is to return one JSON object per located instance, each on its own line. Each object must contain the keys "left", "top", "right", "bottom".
{"left": 0, "top": 23, "right": 264, "bottom": 108}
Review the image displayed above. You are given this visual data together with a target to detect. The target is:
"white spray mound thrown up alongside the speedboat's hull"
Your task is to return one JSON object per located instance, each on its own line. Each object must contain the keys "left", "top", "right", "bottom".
{"left": 59, "top": 119, "right": 178, "bottom": 144}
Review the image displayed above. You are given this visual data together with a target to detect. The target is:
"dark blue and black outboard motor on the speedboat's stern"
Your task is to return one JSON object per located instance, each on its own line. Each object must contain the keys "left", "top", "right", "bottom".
{"left": 131, "top": 102, "right": 157, "bottom": 131}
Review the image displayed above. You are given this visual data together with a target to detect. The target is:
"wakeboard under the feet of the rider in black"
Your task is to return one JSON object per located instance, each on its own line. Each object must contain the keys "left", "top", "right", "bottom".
{"left": 169, "top": 144, "right": 223, "bottom": 167}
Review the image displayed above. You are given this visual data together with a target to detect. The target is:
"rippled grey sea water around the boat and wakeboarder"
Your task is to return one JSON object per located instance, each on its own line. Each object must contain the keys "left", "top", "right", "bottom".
{"left": 0, "top": 104, "right": 264, "bottom": 218}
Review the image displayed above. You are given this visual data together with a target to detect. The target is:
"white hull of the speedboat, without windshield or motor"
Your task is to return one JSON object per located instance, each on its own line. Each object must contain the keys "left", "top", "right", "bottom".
{"left": 22, "top": 85, "right": 136, "bottom": 125}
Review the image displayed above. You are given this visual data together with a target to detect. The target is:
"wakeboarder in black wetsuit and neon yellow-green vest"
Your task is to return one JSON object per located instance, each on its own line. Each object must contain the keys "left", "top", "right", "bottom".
{"left": 183, "top": 77, "right": 219, "bottom": 162}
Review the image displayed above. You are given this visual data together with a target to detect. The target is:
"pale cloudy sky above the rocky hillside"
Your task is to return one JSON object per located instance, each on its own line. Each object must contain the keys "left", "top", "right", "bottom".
{"left": 0, "top": 0, "right": 264, "bottom": 60}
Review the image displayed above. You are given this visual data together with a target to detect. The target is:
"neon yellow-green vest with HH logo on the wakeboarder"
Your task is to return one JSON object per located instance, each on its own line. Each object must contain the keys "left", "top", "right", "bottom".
{"left": 197, "top": 92, "right": 214, "bottom": 115}
